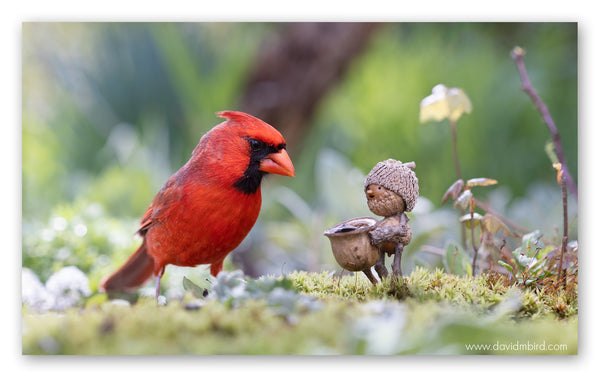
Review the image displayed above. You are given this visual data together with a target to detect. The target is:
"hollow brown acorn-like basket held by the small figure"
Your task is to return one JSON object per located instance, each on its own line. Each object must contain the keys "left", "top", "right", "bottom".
{"left": 324, "top": 217, "right": 379, "bottom": 271}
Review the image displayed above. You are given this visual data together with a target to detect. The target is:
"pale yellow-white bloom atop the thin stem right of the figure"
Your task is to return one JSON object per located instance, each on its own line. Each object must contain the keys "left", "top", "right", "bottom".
{"left": 419, "top": 84, "right": 472, "bottom": 123}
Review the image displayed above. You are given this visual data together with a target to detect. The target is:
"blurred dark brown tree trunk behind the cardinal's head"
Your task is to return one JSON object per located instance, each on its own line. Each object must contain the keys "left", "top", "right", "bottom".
{"left": 240, "top": 23, "right": 378, "bottom": 153}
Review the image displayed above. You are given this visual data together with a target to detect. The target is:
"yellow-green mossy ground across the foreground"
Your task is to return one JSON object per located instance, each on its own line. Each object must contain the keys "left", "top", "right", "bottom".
{"left": 22, "top": 268, "right": 577, "bottom": 355}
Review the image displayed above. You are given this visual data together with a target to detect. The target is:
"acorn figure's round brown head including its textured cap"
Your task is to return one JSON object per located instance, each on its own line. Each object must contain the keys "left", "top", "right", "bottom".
{"left": 364, "top": 159, "right": 419, "bottom": 216}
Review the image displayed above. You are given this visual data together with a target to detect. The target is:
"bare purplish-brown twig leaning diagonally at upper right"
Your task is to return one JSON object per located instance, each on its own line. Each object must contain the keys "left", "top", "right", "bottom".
{"left": 510, "top": 47, "right": 578, "bottom": 200}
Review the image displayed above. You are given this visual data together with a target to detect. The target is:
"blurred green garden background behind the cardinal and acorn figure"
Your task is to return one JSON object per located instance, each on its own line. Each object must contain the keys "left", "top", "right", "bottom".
{"left": 22, "top": 23, "right": 578, "bottom": 289}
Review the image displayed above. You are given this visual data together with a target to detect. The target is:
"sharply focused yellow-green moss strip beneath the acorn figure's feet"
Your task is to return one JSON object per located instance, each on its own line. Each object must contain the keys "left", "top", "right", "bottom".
{"left": 288, "top": 267, "right": 577, "bottom": 318}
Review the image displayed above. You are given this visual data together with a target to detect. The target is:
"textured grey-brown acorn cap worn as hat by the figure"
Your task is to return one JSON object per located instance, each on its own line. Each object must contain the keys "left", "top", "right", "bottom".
{"left": 364, "top": 158, "right": 419, "bottom": 212}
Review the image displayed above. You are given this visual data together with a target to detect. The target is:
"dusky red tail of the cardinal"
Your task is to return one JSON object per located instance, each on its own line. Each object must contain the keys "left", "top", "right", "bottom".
{"left": 100, "top": 240, "right": 154, "bottom": 292}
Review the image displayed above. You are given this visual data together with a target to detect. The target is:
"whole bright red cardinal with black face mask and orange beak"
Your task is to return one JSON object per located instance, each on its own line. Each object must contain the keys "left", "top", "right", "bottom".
{"left": 100, "top": 111, "right": 295, "bottom": 297}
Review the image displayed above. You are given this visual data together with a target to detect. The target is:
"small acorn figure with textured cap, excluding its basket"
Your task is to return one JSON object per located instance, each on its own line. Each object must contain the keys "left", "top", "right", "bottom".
{"left": 364, "top": 159, "right": 419, "bottom": 278}
